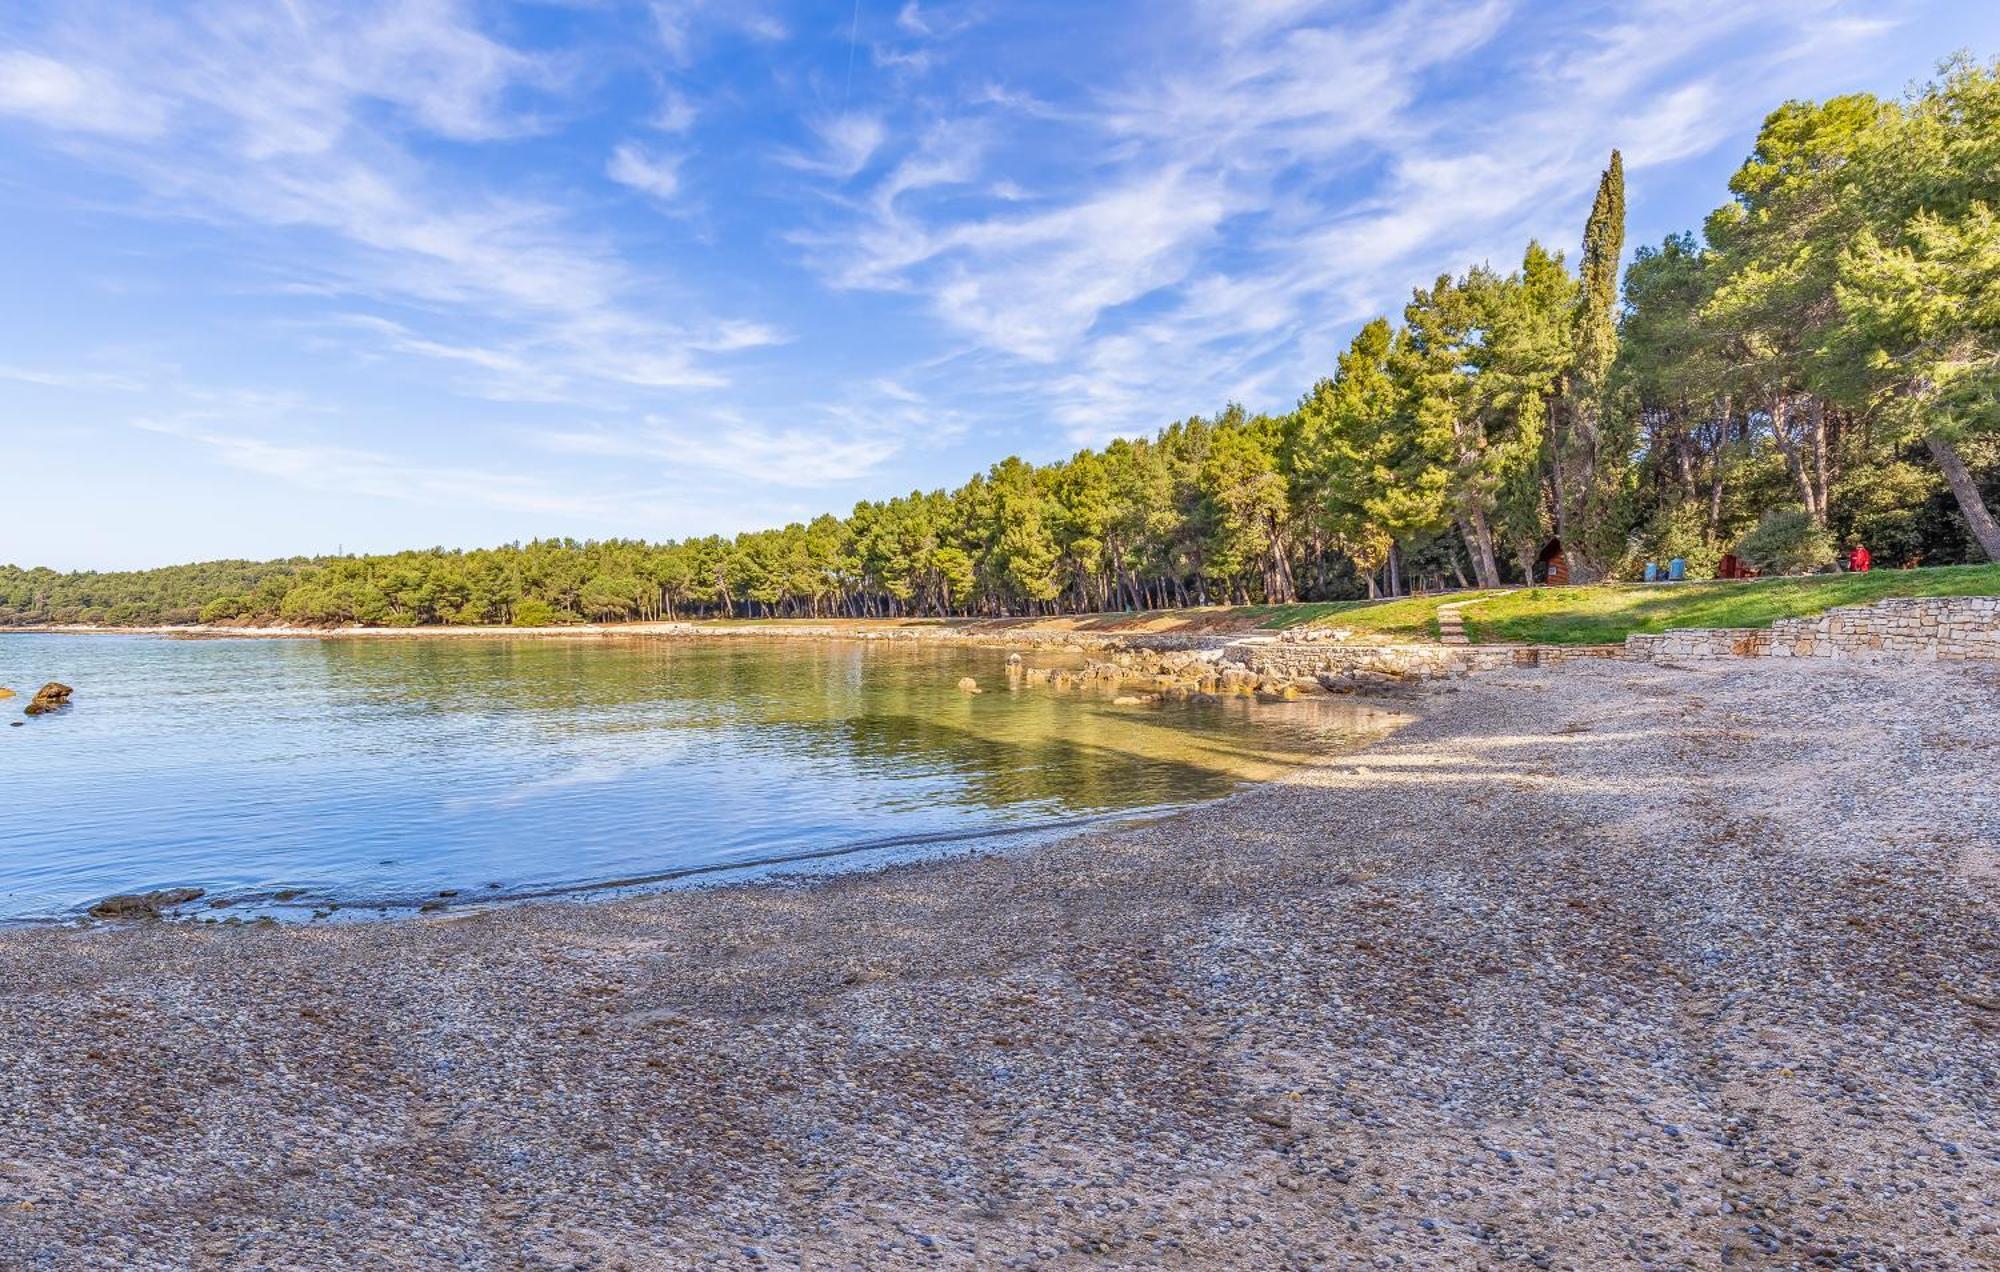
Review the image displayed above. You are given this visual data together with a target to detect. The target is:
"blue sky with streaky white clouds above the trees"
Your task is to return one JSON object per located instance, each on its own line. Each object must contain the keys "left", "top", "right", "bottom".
{"left": 0, "top": 0, "right": 2000, "bottom": 568}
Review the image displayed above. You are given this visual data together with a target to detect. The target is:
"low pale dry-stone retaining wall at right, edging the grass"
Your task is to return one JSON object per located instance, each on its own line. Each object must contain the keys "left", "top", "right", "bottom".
{"left": 1626, "top": 596, "right": 2000, "bottom": 662}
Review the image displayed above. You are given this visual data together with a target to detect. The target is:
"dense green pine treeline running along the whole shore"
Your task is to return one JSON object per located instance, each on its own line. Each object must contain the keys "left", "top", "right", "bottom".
{"left": 0, "top": 62, "right": 2000, "bottom": 624}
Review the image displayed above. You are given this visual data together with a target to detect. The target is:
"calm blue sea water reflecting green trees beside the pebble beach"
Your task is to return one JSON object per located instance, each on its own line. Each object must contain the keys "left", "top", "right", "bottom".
{"left": 0, "top": 634, "right": 1380, "bottom": 920}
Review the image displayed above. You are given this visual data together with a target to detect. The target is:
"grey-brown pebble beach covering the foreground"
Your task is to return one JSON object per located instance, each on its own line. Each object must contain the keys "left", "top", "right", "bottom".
{"left": 0, "top": 662, "right": 2000, "bottom": 1270}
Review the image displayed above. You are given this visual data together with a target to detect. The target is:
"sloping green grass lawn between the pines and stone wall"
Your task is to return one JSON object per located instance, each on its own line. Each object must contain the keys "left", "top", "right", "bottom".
{"left": 1464, "top": 564, "right": 2000, "bottom": 644}
